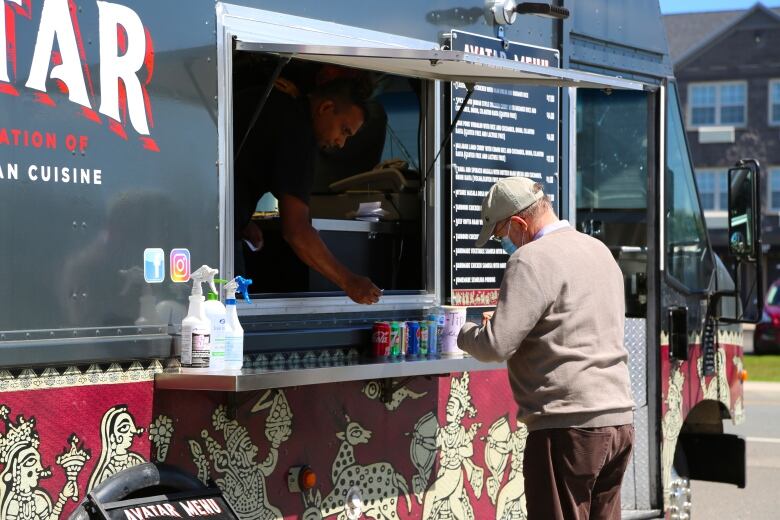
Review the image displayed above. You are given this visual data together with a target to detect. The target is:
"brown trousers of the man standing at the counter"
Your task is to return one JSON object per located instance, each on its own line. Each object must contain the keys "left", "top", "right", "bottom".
{"left": 523, "top": 424, "right": 634, "bottom": 520}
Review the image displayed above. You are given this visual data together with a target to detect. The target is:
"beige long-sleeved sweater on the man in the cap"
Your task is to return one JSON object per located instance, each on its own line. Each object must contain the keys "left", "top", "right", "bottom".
{"left": 458, "top": 227, "right": 634, "bottom": 430}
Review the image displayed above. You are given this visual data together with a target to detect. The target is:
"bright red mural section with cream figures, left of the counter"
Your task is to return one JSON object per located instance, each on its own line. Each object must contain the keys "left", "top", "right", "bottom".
{"left": 0, "top": 363, "right": 159, "bottom": 520}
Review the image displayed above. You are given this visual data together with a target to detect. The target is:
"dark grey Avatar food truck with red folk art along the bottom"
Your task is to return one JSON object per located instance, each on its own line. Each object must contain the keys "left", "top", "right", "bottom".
{"left": 0, "top": 0, "right": 761, "bottom": 520}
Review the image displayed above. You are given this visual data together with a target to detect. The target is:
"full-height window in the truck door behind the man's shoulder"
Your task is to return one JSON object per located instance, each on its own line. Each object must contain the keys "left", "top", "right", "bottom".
{"left": 576, "top": 89, "right": 649, "bottom": 318}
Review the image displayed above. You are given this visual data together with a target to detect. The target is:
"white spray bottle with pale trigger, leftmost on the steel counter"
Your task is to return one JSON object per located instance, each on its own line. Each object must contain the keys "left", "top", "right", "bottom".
{"left": 181, "top": 265, "right": 217, "bottom": 368}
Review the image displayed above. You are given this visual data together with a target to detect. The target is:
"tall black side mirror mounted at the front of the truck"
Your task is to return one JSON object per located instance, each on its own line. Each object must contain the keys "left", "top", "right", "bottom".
{"left": 712, "top": 159, "right": 764, "bottom": 323}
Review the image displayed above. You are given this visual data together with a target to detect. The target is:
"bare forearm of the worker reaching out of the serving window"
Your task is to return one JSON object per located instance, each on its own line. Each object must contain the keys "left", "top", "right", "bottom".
{"left": 279, "top": 194, "right": 382, "bottom": 304}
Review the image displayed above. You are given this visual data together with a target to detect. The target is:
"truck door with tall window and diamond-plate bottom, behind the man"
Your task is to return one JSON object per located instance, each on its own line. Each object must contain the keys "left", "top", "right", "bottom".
{"left": 573, "top": 89, "right": 657, "bottom": 510}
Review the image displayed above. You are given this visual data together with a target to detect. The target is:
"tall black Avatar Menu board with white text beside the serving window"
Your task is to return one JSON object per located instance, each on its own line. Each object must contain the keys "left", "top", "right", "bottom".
{"left": 450, "top": 31, "right": 560, "bottom": 307}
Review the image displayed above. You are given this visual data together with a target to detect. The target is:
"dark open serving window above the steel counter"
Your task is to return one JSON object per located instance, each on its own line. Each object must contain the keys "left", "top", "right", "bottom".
{"left": 232, "top": 50, "right": 432, "bottom": 305}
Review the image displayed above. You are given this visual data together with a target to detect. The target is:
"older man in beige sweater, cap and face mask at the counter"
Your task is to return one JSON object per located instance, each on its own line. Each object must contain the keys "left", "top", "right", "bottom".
{"left": 458, "top": 178, "right": 634, "bottom": 520}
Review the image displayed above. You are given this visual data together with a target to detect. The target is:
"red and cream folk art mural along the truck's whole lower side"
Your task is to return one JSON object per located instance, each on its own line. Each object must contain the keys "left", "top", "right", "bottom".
{"left": 0, "top": 344, "right": 742, "bottom": 520}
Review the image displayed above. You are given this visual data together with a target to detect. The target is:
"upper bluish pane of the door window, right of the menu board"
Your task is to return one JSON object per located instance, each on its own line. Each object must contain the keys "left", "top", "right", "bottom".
{"left": 577, "top": 89, "right": 647, "bottom": 210}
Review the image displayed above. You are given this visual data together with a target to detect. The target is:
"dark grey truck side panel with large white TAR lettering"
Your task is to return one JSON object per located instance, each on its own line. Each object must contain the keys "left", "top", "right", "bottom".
{"left": 0, "top": 0, "right": 219, "bottom": 334}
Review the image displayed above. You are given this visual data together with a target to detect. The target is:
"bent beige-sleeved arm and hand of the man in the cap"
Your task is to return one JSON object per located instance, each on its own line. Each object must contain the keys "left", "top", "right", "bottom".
{"left": 458, "top": 259, "right": 552, "bottom": 361}
